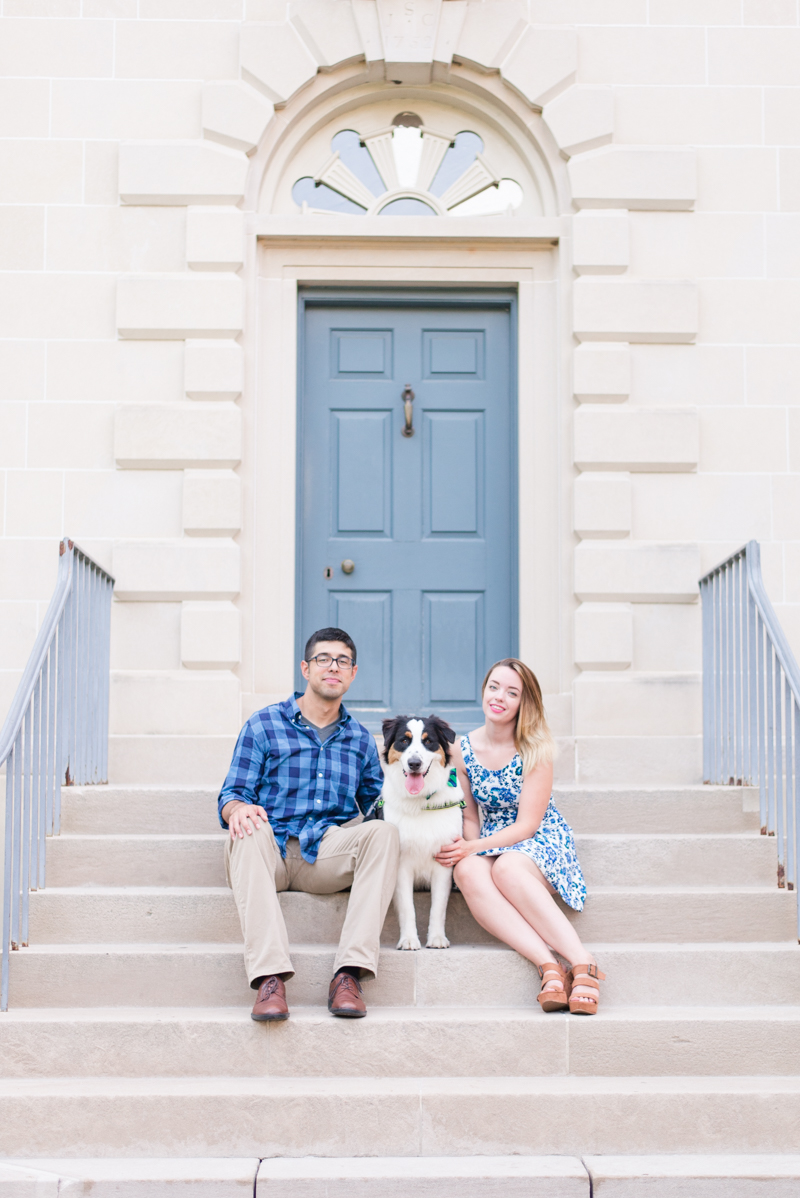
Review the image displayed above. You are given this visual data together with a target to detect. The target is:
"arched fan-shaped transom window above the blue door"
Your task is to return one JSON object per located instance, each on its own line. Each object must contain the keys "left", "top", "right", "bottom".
{"left": 291, "top": 111, "right": 525, "bottom": 217}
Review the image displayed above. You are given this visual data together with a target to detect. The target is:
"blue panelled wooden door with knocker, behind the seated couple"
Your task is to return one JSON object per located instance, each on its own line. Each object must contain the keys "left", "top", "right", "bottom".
{"left": 298, "top": 300, "right": 516, "bottom": 727}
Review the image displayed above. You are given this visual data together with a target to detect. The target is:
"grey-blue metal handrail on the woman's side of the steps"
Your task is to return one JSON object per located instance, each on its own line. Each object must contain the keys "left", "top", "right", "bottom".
{"left": 699, "top": 540, "right": 800, "bottom": 939}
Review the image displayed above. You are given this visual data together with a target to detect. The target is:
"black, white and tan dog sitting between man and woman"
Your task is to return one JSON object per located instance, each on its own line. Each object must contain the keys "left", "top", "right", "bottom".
{"left": 381, "top": 715, "right": 463, "bottom": 949}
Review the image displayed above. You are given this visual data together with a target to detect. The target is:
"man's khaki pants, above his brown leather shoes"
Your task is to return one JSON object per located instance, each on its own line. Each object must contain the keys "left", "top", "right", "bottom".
{"left": 225, "top": 819, "right": 399, "bottom": 984}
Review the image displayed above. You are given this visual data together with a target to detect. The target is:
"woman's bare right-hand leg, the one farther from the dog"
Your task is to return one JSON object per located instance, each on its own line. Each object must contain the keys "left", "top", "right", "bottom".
{"left": 492, "top": 852, "right": 596, "bottom": 997}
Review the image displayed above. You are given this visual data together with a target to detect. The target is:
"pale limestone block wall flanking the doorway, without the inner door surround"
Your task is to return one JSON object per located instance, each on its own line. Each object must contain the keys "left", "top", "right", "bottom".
{"left": 0, "top": 0, "right": 800, "bottom": 781}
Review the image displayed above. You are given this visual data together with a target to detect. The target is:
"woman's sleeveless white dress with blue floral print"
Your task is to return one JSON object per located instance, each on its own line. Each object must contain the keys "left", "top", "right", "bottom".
{"left": 461, "top": 737, "right": 586, "bottom": 910}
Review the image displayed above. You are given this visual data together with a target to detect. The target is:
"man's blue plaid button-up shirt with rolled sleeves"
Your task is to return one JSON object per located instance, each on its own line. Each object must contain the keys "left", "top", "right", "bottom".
{"left": 217, "top": 695, "right": 383, "bottom": 863}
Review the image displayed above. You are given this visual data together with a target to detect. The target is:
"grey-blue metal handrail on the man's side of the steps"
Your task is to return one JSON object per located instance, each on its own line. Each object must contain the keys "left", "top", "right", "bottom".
{"left": 0, "top": 538, "right": 114, "bottom": 1011}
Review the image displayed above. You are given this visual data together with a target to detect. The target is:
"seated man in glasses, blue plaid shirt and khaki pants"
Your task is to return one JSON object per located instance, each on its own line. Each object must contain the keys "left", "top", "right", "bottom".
{"left": 218, "top": 628, "right": 398, "bottom": 1022}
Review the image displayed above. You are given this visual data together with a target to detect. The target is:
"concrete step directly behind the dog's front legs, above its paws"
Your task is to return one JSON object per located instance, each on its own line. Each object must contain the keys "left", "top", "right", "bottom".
{"left": 30, "top": 887, "right": 796, "bottom": 945}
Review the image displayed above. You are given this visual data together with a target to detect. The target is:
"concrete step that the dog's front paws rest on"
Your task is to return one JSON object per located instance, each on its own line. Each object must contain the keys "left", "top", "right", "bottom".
{"left": 10, "top": 942, "right": 800, "bottom": 1006}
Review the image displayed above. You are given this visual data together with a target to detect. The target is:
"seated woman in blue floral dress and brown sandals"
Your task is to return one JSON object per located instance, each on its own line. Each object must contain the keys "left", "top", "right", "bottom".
{"left": 436, "top": 658, "right": 605, "bottom": 1015}
